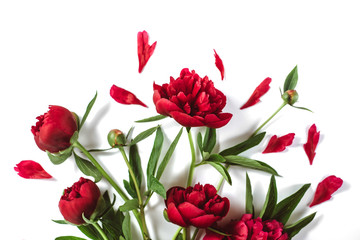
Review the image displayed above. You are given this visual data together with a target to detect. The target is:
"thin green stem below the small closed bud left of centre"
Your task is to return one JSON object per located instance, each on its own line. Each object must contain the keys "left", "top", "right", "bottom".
{"left": 119, "top": 147, "right": 150, "bottom": 239}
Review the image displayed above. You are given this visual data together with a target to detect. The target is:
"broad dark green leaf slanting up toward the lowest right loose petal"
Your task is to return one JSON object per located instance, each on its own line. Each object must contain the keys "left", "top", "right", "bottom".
{"left": 272, "top": 183, "right": 310, "bottom": 225}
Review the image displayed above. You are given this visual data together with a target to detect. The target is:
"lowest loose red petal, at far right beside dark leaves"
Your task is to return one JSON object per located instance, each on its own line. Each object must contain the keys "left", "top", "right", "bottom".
{"left": 310, "top": 175, "right": 343, "bottom": 207}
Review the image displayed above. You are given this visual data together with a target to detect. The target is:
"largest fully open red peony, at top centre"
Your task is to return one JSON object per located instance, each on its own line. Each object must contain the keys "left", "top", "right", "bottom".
{"left": 153, "top": 68, "right": 232, "bottom": 128}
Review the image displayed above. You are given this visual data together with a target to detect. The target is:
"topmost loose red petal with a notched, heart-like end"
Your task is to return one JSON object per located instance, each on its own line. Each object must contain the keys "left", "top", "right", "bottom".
{"left": 137, "top": 31, "right": 156, "bottom": 73}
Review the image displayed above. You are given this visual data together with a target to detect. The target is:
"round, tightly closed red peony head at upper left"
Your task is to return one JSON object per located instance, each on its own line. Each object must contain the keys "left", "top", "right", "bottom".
{"left": 31, "top": 105, "right": 78, "bottom": 153}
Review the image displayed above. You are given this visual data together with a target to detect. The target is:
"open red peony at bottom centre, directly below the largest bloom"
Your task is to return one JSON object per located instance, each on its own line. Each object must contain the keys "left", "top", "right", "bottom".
{"left": 165, "top": 184, "right": 230, "bottom": 228}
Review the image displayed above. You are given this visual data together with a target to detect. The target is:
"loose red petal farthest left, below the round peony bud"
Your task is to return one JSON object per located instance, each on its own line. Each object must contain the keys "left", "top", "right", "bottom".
{"left": 14, "top": 160, "right": 52, "bottom": 179}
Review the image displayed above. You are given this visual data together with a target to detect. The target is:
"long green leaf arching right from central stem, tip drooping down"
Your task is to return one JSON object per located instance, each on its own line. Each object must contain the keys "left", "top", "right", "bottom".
{"left": 224, "top": 155, "right": 279, "bottom": 176}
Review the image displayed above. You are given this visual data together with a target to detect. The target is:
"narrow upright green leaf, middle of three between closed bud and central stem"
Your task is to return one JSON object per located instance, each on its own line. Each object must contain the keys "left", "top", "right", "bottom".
{"left": 146, "top": 127, "right": 164, "bottom": 189}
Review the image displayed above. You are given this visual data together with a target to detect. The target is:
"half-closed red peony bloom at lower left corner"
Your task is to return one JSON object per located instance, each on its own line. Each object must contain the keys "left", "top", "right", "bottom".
{"left": 59, "top": 178, "right": 101, "bottom": 225}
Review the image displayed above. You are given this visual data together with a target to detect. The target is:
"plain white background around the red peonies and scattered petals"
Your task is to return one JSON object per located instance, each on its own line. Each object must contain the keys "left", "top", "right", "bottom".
{"left": 0, "top": 0, "right": 360, "bottom": 240}
